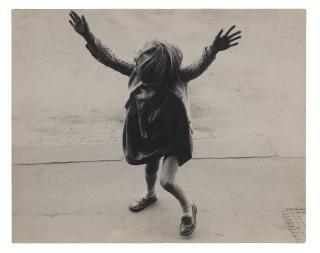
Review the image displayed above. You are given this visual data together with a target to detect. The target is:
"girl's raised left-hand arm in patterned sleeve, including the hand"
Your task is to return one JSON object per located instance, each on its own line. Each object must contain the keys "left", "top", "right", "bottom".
{"left": 69, "top": 11, "right": 134, "bottom": 76}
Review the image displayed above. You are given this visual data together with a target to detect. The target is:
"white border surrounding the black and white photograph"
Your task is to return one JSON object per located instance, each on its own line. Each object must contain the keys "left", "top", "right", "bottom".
{"left": 0, "top": 0, "right": 320, "bottom": 253}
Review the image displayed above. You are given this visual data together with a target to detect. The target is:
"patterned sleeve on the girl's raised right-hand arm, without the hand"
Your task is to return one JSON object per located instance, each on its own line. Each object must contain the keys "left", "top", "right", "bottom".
{"left": 180, "top": 47, "right": 217, "bottom": 83}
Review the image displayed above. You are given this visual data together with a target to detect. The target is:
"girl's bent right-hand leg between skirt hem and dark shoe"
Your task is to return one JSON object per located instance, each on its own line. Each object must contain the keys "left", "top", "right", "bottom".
{"left": 160, "top": 156, "right": 192, "bottom": 217}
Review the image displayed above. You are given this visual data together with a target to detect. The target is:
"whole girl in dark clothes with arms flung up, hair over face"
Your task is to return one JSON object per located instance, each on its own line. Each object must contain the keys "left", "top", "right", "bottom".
{"left": 69, "top": 11, "right": 241, "bottom": 236}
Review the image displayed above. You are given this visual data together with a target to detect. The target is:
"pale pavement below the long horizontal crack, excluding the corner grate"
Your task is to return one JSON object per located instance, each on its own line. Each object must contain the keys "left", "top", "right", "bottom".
{"left": 13, "top": 158, "right": 305, "bottom": 243}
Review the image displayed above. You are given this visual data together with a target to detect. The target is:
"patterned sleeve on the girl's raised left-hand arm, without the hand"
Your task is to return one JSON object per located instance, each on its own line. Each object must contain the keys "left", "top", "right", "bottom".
{"left": 86, "top": 38, "right": 134, "bottom": 76}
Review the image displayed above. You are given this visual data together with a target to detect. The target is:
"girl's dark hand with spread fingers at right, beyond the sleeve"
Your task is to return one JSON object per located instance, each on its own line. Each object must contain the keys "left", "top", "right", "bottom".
{"left": 211, "top": 25, "right": 241, "bottom": 52}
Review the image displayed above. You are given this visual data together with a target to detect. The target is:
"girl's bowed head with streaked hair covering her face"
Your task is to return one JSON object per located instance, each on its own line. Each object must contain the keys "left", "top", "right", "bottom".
{"left": 136, "top": 41, "right": 182, "bottom": 86}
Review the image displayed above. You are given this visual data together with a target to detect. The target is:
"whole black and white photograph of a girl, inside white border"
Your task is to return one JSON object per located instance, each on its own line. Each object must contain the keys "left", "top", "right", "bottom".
{"left": 11, "top": 8, "right": 307, "bottom": 243}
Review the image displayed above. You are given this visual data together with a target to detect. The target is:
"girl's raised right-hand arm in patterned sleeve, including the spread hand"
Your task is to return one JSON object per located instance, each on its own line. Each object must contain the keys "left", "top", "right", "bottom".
{"left": 180, "top": 26, "right": 241, "bottom": 82}
